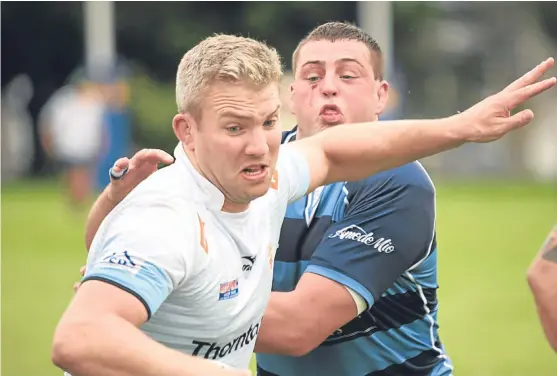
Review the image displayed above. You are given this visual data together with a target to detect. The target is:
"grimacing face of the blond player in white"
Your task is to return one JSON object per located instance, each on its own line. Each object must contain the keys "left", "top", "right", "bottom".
{"left": 194, "top": 83, "right": 281, "bottom": 211}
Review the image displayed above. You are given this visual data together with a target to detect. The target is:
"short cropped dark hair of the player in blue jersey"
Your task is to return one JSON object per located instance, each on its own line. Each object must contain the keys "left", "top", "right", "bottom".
{"left": 292, "top": 21, "right": 383, "bottom": 80}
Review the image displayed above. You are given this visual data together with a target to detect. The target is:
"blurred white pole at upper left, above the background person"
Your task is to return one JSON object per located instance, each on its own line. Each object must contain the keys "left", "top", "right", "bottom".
{"left": 84, "top": 1, "right": 116, "bottom": 79}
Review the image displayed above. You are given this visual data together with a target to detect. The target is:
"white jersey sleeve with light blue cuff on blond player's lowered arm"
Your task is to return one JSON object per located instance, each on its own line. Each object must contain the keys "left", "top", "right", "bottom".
{"left": 83, "top": 205, "right": 196, "bottom": 318}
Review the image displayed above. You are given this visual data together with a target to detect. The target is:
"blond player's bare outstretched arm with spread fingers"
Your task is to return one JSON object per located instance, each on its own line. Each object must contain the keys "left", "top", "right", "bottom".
{"left": 292, "top": 58, "right": 556, "bottom": 192}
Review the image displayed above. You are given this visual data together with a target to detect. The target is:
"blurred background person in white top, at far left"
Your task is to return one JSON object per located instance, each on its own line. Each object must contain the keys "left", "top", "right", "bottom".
{"left": 39, "top": 79, "right": 106, "bottom": 209}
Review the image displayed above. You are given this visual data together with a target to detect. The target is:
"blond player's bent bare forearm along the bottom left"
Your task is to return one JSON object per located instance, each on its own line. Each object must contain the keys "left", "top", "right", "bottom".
{"left": 53, "top": 317, "right": 226, "bottom": 376}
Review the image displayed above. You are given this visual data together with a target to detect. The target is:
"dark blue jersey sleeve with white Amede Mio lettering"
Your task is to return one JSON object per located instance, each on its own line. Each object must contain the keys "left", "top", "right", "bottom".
{"left": 306, "top": 164, "right": 435, "bottom": 308}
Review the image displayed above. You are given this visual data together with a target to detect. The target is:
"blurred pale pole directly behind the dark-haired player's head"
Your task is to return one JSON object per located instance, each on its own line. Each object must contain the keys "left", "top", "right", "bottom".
{"left": 357, "top": 1, "right": 394, "bottom": 80}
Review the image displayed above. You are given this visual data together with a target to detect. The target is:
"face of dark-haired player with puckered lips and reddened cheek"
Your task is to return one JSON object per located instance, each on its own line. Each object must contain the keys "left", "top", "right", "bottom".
{"left": 291, "top": 40, "right": 388, "bottom": 137}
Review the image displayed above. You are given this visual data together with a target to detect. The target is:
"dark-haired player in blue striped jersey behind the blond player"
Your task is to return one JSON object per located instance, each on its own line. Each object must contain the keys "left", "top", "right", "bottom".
{"left": 80, "top": 23, "right": 551, "bottom": 376}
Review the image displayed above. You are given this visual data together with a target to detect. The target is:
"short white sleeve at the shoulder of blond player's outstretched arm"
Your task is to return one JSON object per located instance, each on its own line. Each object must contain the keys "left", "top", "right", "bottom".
{"left": 271, "top": 145, "right": 310, "bottom": 203}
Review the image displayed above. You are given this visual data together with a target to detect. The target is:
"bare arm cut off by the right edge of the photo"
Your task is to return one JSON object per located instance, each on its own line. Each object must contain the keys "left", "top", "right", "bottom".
{"left": 528, "top": 225, "right": 557, "bottom": 352}
